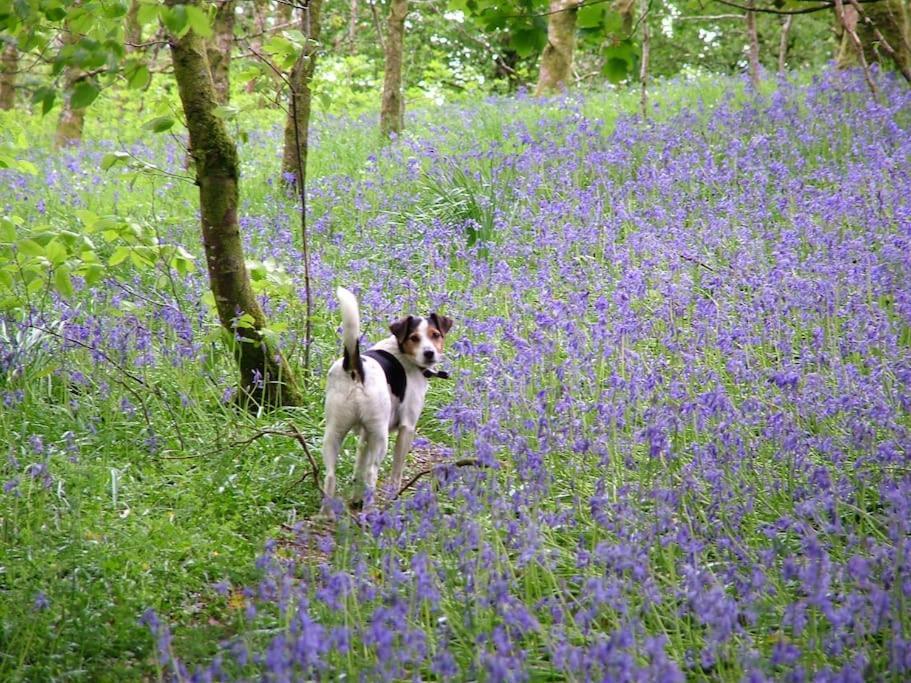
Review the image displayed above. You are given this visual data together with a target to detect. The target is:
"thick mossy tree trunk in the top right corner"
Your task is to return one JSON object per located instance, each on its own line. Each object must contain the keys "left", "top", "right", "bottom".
{"left": 836, "top": 0, "right": 911, "bottom": 71}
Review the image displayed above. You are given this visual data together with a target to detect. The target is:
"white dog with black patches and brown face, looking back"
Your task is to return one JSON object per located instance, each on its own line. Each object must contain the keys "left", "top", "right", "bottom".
{"left": 323, "top": 287, "right": 453, "bottom": 517}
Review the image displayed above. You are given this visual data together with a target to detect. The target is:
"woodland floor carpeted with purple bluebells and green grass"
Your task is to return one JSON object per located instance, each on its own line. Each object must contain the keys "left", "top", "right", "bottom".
{"left": 0, "top": 73, "right": 911, "bottom": 681}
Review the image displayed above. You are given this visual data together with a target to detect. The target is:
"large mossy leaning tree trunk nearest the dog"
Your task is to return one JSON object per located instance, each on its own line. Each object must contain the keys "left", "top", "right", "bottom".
{"left": 168, "top": 0, "right": 301, "bottom": 406}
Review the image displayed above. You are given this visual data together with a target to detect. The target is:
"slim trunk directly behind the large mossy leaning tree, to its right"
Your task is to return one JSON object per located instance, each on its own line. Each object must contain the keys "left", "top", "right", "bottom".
{"left": 282, "top": 0, "right": 323, "bottom": 188}
